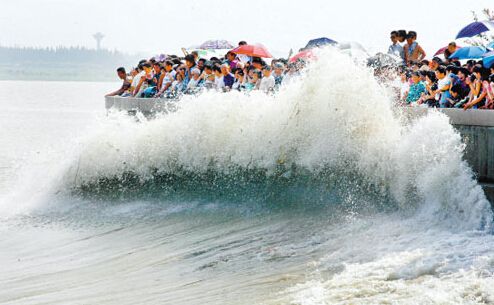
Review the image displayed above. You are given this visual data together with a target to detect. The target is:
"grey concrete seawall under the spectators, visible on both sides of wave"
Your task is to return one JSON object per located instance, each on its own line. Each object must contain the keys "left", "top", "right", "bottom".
{"left": 105, "top": 97, "right": 494, "bottom": 205}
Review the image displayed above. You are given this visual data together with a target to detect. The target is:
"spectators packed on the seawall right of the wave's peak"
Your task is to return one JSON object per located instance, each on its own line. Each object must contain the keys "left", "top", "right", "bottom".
{"left": 388, "top": 30, "right": 494, "bottom": 109}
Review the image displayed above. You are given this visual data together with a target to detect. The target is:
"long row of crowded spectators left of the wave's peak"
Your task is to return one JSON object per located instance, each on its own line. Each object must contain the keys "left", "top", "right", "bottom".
{"left": 107, "top": 41, "right": 303, "bottom": 98}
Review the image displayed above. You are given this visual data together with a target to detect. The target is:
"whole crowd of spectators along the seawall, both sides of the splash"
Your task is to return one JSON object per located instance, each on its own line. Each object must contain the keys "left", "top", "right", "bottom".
{"left": 107, "top": 35, "right": 494, "bottom": 109}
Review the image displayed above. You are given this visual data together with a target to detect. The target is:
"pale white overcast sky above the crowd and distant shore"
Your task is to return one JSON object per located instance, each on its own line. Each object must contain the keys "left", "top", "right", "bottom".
{"left": 0, "top": 0, "right": 494, "bottom": 57}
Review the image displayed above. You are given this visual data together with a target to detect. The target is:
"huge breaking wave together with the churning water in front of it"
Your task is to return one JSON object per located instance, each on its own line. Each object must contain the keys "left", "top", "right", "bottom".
{"left": 0, "top": 49, "right": 494, "bottom": 305}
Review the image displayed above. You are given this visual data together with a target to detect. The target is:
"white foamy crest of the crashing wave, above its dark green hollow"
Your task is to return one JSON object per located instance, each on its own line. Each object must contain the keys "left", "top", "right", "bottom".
{"left": 58, "top": 49, "right": 492, "bottom": 228}
